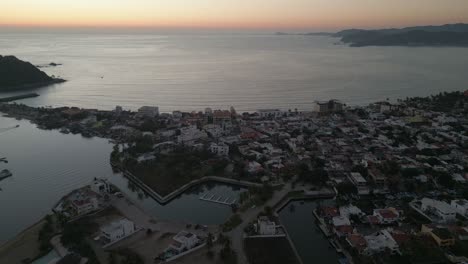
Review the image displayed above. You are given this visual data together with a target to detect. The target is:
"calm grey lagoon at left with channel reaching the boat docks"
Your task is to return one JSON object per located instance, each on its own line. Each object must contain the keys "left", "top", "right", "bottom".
{"left": 0, "top": 116, "right": 242, "bottom": 244}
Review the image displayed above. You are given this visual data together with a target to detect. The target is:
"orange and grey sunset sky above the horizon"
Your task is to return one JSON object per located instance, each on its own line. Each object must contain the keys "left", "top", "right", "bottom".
{"left": 0, "top": 0, "right": 468, "bottom": 30}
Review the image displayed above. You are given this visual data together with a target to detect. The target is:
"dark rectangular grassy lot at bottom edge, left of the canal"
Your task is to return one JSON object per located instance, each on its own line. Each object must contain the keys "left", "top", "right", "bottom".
{"left": 245, "top": 237, "right": 299, "bottom": 264}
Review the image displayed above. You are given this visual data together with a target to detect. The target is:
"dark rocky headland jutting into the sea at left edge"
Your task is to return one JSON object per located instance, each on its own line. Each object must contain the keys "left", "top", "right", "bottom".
{"left": 0, "top": 55, "right": 65, "bottom": 92}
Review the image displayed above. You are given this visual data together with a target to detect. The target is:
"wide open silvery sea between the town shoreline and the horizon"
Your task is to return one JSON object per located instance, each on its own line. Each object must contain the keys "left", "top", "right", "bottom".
{"left": 0, "top": 33, "right": 468, "bottom": 111}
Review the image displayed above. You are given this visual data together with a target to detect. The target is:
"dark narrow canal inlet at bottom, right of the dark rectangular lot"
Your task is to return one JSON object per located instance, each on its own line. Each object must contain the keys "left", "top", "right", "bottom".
{"left": 279, "top": 201, "right": 339, "bottom": 264}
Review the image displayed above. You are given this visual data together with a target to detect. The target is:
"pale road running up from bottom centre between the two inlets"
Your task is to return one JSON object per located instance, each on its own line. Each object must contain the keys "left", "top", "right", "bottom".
{"left": 226, "top": 183, "right": 293, "bottom": 264}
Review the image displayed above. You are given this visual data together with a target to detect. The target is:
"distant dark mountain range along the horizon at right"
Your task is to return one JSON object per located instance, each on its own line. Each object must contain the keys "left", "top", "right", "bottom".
{"left": 276, "top": 23, "right": 468, "bottom": 47}
